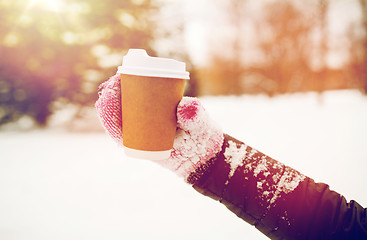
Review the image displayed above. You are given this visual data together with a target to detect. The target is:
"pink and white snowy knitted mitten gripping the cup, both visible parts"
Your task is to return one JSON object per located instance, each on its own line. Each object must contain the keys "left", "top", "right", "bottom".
{"left": 95, "top": 74, "right": 223, "bottom": 179}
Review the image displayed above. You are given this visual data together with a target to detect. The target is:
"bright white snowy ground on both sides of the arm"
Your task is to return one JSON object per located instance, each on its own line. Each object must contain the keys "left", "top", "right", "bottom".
{"left": 0, "top": 91, "right": 367, "bottom": 240}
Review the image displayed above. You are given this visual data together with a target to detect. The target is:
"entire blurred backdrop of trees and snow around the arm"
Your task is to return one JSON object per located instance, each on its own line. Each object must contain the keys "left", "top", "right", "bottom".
{"left": 0, "top": 0, "right": 367, "bottom": 240}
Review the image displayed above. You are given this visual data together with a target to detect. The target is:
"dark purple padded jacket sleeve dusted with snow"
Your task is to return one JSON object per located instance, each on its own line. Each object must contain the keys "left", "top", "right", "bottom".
{"left": 188, "top": 135, "right": 367, "bottom": 239}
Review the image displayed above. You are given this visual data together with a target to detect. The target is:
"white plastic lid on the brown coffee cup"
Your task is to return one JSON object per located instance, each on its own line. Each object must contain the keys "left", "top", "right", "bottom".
{"left": 117, "top": 49, "right": 190, "bottom": 79}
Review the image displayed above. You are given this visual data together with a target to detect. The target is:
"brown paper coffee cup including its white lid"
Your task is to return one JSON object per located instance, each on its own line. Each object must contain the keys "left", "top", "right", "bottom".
{"left": 117, "top": 49, "right": 189, "bottom": 160}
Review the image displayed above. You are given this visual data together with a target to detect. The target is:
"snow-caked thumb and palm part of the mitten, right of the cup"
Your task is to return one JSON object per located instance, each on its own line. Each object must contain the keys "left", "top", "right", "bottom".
{"left": 158, "top": 97, "right": 224, "bottom": 180}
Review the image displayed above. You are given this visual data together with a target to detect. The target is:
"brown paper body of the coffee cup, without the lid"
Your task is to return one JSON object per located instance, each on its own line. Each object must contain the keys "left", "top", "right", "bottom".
{"left": 121, "top": 74, "right": 185, "bottom": 160}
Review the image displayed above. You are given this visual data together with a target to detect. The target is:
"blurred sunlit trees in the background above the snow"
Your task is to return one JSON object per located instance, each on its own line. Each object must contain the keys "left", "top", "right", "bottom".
{"left": 0, "top": 0, "right": 367, "bottom": 129}
